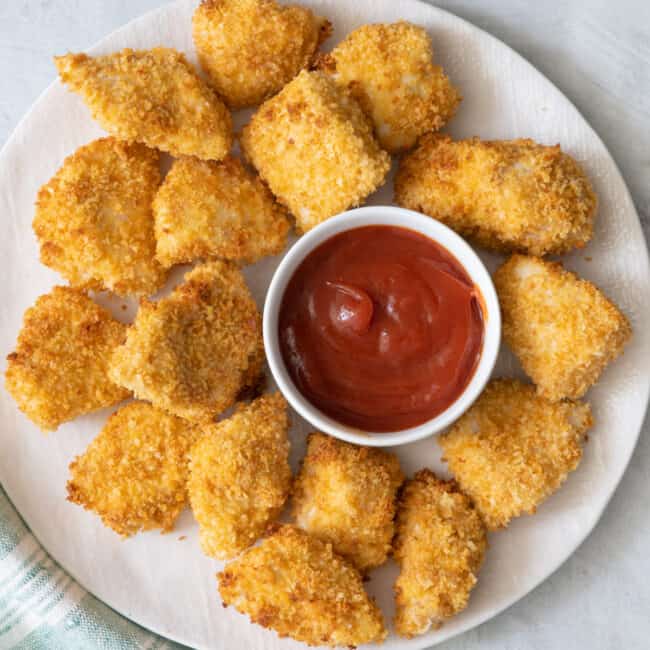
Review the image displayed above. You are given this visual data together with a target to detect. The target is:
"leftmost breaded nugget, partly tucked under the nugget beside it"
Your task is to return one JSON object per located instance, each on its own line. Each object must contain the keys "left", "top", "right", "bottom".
{"left": 5, "top": 287, "right": 130, "bottom": 431}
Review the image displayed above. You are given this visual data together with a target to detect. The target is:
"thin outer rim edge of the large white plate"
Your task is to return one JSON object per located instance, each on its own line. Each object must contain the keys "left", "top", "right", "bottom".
{"left": 0, "top": 0, "right": 650, "bottom": 650}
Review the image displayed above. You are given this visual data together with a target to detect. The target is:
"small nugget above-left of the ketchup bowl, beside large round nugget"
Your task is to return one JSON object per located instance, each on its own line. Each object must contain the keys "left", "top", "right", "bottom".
{"left": 153, "top": 157, "right": 289, "bottom": 267}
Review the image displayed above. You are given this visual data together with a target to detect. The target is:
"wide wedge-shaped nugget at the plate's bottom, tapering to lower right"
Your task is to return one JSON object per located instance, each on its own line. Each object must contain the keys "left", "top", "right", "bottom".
{"left": 217, "top": 525, "right": 386, "bottom": 647}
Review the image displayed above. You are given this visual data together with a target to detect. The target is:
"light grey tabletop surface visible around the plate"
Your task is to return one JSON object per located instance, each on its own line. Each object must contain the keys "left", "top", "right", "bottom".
{"left": 0, "top": 0, "right": 650, "bottom": 650}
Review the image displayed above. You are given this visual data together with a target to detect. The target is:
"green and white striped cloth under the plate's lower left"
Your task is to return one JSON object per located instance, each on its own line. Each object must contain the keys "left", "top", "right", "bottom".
{"left": 0, "top": 487, "right": 184, "bottom": 650}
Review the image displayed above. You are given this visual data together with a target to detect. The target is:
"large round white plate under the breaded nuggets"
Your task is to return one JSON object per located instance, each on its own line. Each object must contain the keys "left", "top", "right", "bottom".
{"left": 0, "top": 0, "right": 650, "bottom": 650}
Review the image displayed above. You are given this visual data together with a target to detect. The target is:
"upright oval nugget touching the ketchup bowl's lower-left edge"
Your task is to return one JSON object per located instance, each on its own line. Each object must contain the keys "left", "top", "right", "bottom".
{"left": 188, "top": 393, "right": 291, "bottom": 559}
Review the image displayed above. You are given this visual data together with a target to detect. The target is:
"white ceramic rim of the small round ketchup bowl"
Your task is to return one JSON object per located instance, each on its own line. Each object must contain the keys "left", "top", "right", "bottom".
{"left": 264, "top": 206, "right": 501, "bottom": 447}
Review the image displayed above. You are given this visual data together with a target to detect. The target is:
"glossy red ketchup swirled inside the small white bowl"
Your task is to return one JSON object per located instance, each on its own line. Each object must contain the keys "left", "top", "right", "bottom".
{"left": 279, "top": 226, "right": 484, "bottom": 432}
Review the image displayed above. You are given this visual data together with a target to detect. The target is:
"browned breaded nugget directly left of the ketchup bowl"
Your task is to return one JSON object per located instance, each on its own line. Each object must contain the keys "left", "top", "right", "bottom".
{"left": 110, "top": 262, "right": 264, "bottom": 423}
